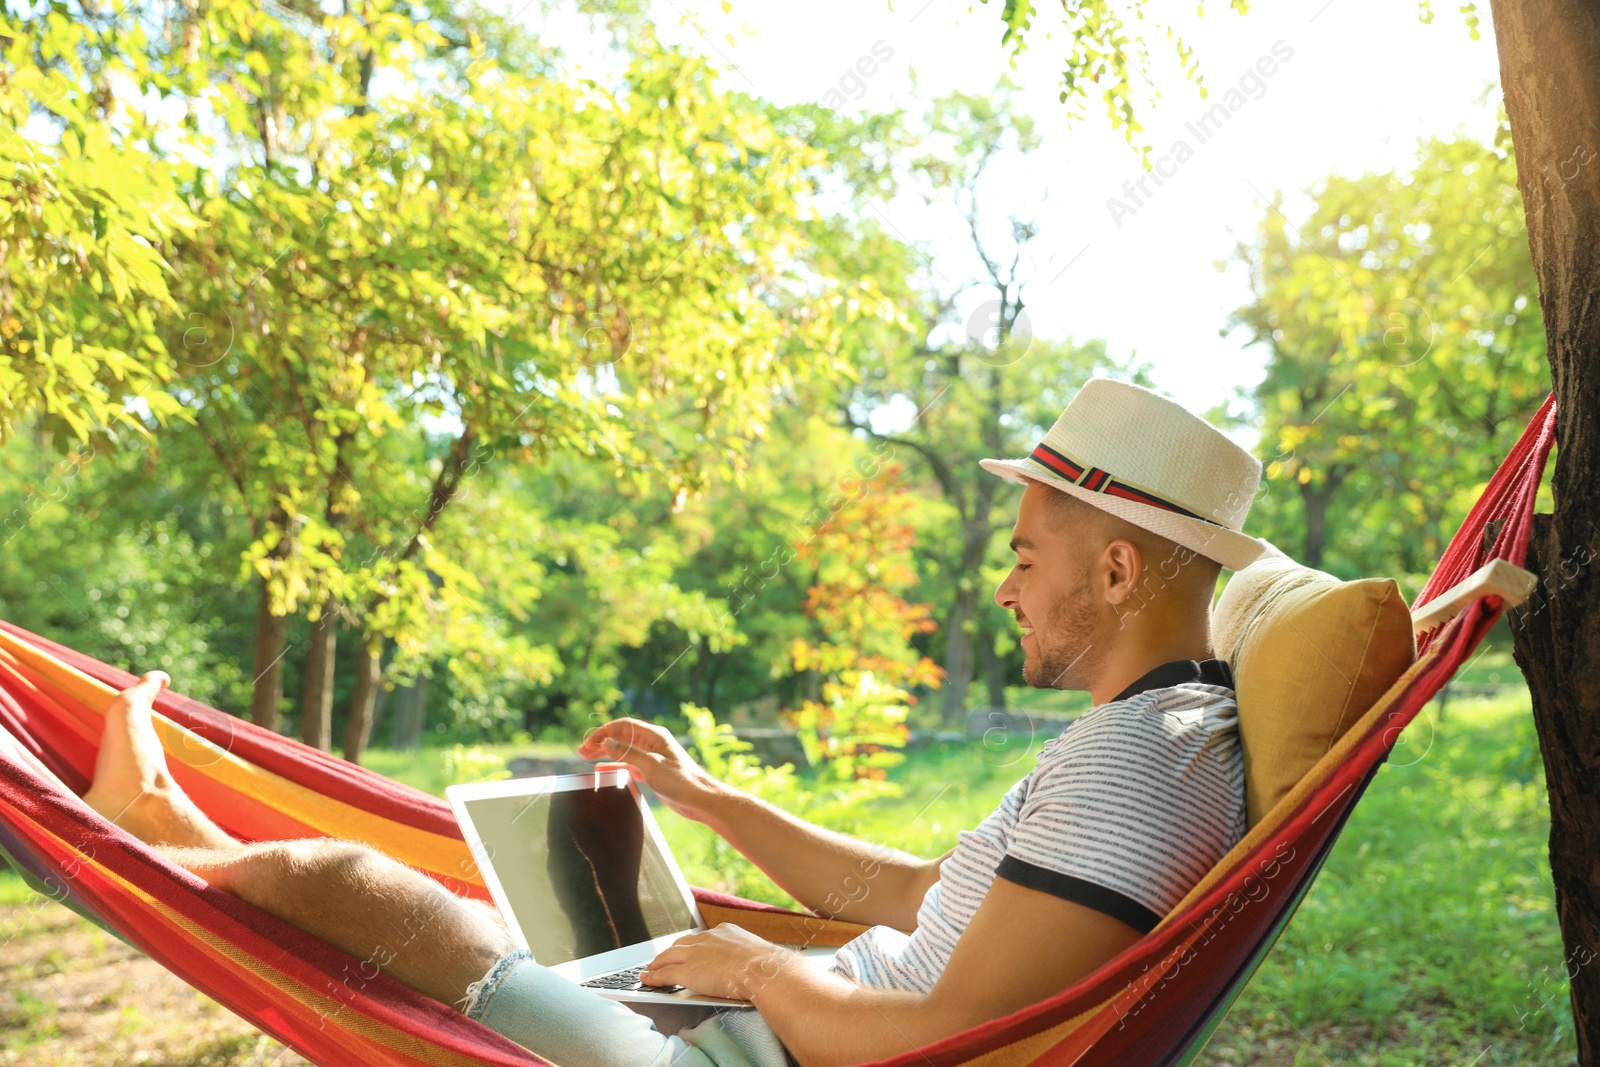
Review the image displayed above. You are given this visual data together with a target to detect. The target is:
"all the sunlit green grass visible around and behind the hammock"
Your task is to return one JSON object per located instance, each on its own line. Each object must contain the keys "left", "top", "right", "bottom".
{"left": 0, "top": 681, "right": 1574, "bottom": 1067}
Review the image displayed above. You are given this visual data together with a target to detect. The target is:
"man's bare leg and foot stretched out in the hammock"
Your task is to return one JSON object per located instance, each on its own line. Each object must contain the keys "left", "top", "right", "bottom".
{"left": 83, "top": 672, "right": 512, "bottom": 1003}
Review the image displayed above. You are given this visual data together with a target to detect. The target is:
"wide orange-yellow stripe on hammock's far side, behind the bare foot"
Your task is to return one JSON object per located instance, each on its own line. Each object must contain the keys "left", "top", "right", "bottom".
{"left": 0, "top": 630, "right": 483, "bottom": 886}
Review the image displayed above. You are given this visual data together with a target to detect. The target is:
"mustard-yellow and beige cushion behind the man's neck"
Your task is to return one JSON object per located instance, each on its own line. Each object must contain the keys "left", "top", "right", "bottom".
{"left": 1211, "top": 549, "right": 1416, "bottom": 825}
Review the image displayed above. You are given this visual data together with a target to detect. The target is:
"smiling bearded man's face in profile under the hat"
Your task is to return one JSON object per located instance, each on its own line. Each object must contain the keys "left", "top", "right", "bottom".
{"left": 995, "top": 482, "right": 1109, "bottom": 691}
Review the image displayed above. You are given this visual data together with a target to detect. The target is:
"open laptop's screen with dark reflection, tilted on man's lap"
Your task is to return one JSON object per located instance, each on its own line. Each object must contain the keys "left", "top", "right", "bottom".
{"left": 464, "top": 785, "right": 698, "bottom": 966}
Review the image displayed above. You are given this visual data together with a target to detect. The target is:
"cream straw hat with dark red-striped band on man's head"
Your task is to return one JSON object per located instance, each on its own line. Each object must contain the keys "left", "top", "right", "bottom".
{"left": 978, "top": 378, "right": 1266, "bottom": 571}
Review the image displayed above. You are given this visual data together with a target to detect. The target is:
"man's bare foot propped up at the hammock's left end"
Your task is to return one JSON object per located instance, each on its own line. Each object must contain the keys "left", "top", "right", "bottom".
{"left": 83, "top": 670, "right": 237, "bottom": 846}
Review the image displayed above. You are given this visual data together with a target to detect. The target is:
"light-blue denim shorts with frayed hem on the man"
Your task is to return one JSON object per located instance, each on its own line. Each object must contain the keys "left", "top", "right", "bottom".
{"left": 462, "top": 950, "right": 794, "bottom": 1067}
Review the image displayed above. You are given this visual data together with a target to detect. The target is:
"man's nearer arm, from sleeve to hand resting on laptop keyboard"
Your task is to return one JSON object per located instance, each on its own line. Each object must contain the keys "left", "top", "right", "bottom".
{"left": 642, "top": 878, "right": 1141, "bottom": 1067}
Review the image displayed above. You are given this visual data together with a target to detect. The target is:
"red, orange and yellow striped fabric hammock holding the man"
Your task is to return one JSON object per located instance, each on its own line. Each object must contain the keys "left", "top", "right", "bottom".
{"left": 0, "top": 395, "right": 1555, "bottom": 1067}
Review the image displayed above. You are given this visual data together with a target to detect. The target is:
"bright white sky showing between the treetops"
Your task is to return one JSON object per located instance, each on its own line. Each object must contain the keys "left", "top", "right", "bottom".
{"left": 531, "top": 0, "right": 1499, "bottom": 446}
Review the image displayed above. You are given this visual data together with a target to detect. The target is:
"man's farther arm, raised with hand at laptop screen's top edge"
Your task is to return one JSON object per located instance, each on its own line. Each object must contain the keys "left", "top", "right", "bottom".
{"left": 578, "top": 718, "right": 949, "bottom": 931}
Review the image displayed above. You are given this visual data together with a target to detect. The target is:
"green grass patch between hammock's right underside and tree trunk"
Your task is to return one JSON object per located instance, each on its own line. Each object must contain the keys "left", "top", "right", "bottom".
{"left": 1211, "top": 691, "right": 1576, "bottom": 1065}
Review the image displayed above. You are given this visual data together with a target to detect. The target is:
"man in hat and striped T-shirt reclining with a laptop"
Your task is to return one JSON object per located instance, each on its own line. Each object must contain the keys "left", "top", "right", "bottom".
{"left": 85, "top": 379, "right": 1261, "bottom": 1067}
